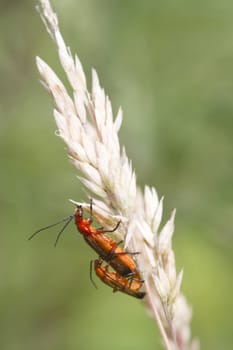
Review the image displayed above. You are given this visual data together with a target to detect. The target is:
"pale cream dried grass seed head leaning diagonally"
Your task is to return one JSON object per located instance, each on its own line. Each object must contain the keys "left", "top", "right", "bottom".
{"left": 36, "top": 0, "right": 199, "bottom": 350}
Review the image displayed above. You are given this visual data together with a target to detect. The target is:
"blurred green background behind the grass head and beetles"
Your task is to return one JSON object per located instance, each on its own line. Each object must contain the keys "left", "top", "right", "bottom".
{"left": 0, "top": 0, "right": 233, "bottom": 350}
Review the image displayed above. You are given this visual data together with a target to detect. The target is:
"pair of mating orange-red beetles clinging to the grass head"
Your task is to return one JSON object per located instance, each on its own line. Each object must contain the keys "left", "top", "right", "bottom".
{"left": 29, "top": 200, "right": 145, "bottom": 299}
